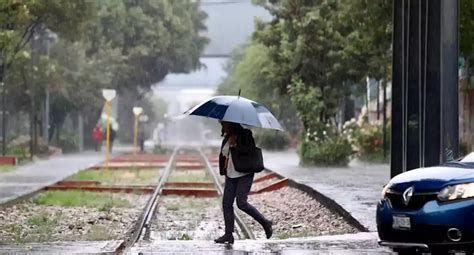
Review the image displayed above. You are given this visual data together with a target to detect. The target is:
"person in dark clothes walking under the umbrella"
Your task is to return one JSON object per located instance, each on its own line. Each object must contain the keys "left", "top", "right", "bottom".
{"left": 214, "top": 121, "right": 273, "bottom": 244}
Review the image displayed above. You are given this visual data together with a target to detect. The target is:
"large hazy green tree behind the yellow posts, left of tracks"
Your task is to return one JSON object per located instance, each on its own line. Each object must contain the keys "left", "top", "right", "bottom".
{"left": 87, "top": 0, "right": 208, "bottom": 141}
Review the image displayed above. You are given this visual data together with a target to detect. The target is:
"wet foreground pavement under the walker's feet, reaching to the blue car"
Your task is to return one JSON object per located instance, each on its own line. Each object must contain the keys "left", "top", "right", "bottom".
{"left": 128, "top": 233, "right": 391, "bottom": 255}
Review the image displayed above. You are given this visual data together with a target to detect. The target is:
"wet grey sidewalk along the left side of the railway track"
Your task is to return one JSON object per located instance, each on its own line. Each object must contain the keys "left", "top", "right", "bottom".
{"left": 0, "top": 147, "right": 129, "bottom": 204}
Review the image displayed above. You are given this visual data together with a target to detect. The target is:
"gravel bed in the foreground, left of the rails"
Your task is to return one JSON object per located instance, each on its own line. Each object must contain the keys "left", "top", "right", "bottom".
{"left": 0, "top": 194, "right": 149, "bottom": 244}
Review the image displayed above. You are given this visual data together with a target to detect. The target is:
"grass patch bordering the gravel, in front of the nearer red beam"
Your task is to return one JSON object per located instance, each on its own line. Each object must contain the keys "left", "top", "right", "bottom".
{"left": 33, "top": 190, "right": 132, "bottom": 211}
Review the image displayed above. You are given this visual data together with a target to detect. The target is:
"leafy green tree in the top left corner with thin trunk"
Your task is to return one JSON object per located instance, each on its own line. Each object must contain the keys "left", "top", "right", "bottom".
{"left": 0, "top": 0, "right": 94, "bottom": 153}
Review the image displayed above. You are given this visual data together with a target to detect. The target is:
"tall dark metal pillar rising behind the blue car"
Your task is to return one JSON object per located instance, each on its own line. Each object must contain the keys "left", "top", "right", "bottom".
{"left": 391, "top": 0, "right": 459, "bottom": 177}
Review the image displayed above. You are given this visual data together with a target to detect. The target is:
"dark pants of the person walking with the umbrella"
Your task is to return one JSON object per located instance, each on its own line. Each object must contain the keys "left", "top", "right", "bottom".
{"left": 222, "top": 174, "right": 268, "bottom": 234}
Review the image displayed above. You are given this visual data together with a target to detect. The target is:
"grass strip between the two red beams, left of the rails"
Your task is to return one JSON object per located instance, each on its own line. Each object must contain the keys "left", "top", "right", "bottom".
{"left": 67, "top": 170, "right": 160, "bottom": 184}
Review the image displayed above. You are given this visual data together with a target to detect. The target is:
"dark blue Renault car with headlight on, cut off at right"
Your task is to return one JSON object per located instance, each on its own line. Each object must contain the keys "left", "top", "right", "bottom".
{"left": 377, "top": 154, "right": 474, "bottom": 254}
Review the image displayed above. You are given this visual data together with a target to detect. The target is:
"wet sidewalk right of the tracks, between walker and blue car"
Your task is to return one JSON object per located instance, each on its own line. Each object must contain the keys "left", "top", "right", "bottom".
{"left": 263, "top": 150, "right": 390, "bottom": 232}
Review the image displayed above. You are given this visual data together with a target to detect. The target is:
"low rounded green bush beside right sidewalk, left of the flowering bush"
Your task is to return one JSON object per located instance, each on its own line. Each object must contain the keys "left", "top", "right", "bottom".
{"left": 300, "top": 132, "right": 353, "bottom": 166}
